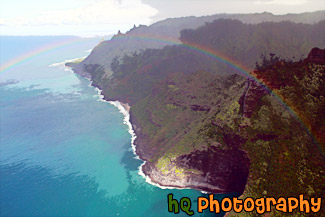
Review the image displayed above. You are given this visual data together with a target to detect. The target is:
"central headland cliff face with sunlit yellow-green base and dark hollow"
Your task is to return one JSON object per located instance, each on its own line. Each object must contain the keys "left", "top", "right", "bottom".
{"left": 131, "top": 71, "right": 249, "bottom": 194}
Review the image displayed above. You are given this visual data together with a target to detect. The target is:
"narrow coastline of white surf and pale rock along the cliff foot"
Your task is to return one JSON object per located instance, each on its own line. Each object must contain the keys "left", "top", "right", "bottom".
{"left": 66, "top": 60, "right": 248, "bottom": 194}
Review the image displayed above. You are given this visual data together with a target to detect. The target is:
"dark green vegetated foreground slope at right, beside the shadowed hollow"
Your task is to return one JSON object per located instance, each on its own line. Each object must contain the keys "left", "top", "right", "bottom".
{"left": 230, "top": 56, "right": 325, "bottom": 216}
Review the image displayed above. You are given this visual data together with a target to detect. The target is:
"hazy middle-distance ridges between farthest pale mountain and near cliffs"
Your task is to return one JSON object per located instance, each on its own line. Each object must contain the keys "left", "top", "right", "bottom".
{"left": 84, "top": 19, "right": 325, "bottom": 105}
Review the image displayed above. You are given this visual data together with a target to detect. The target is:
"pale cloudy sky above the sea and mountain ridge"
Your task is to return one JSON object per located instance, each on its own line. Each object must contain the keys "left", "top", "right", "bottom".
{"left": 0, "top": 0, "right": 325, "bottom": 36}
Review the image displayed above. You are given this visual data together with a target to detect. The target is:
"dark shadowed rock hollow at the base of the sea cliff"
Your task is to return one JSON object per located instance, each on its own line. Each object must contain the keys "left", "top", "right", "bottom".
{"left": 177, "top": 146, "right": 249, "bottom": 194}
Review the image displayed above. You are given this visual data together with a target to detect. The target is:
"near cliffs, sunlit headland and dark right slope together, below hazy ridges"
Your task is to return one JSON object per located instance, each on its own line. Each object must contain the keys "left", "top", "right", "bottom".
{"left": 131, "top": 53, "right": 325, "bottom": 201}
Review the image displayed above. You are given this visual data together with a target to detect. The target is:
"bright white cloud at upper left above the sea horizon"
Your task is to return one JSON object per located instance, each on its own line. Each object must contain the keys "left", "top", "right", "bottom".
{"left": 0, "top": 0, "right": 158, "bottom": 26}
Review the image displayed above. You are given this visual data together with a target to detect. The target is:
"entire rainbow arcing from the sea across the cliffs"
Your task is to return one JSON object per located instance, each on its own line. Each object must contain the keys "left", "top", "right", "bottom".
{"left": 0, "top": 34, "right": 318, "bottom": 155}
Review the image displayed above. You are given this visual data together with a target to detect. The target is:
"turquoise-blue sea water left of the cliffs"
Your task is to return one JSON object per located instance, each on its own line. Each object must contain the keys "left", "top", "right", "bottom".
{"left": 0, "top": 37, "right": 228, "bottom": 216}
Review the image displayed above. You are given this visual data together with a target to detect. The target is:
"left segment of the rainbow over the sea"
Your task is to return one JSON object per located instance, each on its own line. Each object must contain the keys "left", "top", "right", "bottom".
{"left": 0, "top": 37, "right": 83, "bottom": 73}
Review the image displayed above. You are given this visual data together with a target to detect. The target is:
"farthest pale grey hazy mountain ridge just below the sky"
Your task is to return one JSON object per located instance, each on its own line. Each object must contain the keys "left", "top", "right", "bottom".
{"left": 75, "top": 11, "right": 325, "bottom": 77}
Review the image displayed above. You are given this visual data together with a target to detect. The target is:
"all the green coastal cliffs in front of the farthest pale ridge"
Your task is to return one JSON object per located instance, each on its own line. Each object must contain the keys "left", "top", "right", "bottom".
{"left": 70, "top": 14, "right": 325, "bottom": 216}
